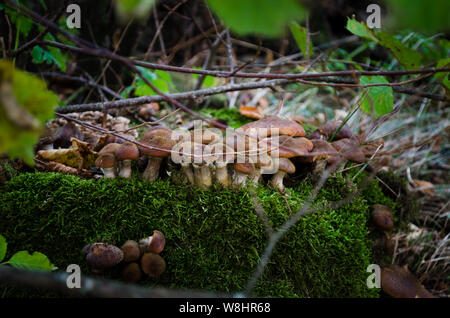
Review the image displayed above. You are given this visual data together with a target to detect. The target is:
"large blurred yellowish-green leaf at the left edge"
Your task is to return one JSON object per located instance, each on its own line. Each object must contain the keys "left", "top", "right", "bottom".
{"left": 0, "top": 60, "right": 58, "bottom": 165}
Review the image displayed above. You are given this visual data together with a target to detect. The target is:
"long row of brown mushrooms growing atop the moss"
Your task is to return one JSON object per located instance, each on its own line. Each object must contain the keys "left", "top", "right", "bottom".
{"left": 84, "top": 115, "right": 379, "bottom": 192}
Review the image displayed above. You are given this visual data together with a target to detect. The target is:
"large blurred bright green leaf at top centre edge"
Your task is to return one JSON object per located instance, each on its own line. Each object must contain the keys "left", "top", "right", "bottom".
{"left": 206, "top": 0, "right": 307, "bottom": 37}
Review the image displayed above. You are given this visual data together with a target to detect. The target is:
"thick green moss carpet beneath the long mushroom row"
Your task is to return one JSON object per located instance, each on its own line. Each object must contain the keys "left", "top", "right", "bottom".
{"left": 0, "top": 173, "right": 398, "bottom": 297}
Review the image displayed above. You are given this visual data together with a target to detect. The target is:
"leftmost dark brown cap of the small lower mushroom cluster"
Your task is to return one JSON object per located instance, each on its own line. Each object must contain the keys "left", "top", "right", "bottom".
{"left": 83, "top": 243, "right": 123, "bottom": 270}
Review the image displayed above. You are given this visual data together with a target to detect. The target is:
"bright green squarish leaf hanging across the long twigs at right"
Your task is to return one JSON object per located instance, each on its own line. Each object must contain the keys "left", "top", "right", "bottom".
{"left": 360, "top": 76, "right": 394, "bottom": 117}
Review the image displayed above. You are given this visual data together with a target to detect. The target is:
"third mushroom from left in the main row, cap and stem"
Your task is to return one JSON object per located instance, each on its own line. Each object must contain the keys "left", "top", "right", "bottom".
{"left": 139, "top": 127, "right": 176, "bottom": 182}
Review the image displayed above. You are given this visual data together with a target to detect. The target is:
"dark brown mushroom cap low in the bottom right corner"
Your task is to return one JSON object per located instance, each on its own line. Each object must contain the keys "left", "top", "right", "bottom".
{"left": 381, "top": 265, "right": 433, "bottom": 298}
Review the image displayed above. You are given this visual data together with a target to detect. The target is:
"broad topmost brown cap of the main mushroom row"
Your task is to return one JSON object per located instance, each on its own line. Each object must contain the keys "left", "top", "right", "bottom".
{"left": 239, "top": 115, "right": 305, "bottom": 137}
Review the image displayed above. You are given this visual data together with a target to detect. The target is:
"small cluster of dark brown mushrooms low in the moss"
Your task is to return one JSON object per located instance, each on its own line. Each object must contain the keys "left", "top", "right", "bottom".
{"left": 82, "top": 230, "right": 166, "bottom": 283}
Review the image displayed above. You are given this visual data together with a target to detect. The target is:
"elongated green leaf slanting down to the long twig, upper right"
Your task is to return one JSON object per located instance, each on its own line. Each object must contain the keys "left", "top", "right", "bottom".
{"left": 377, "top": 32, "right": 422, "bottom": 70}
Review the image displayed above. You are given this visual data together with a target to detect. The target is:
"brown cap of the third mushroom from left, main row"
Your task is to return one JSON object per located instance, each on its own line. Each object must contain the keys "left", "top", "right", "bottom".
{"left": 139, "top": 127, "right": 177, "bottom": 157}
